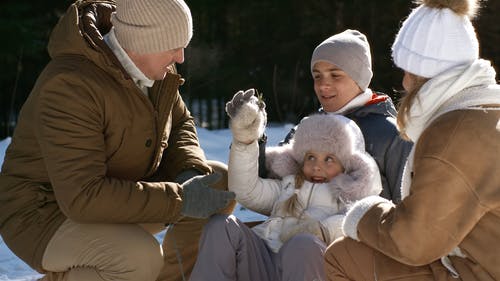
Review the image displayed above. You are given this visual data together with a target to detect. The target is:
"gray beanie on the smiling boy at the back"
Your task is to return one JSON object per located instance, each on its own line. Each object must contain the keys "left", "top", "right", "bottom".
{"left": 311, "top": 29, "right": 373, "bottom": 91}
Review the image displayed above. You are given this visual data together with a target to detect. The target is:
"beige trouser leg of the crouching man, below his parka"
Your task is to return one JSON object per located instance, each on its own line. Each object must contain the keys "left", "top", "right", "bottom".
{"left": 42, "top": 220, "right": 163, "bottom": 281}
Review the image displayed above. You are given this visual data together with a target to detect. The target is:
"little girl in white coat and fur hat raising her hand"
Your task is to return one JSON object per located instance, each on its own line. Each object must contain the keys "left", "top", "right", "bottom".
{"left": 191, "top": 89, "right": 382, "bottom": 281}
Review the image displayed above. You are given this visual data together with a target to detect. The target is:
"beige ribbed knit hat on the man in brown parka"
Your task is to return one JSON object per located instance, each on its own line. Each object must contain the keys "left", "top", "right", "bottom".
{"left": 111, "top": 0, "right": 193, "bottom": 54}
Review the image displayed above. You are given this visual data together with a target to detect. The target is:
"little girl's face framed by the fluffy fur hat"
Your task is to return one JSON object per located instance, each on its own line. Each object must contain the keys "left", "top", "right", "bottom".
{"left": 302, "top": 150, "right": 344, "bottom": 183}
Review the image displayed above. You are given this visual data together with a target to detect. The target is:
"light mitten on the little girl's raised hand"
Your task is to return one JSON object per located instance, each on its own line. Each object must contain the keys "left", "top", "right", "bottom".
{"left": 226, "top": 89, "right": 267, "bottom": 144}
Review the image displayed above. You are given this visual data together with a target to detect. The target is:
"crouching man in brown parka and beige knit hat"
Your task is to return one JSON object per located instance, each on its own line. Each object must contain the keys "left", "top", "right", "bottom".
{"left": 0, "top": 0, "right": 234, "bottom": 280}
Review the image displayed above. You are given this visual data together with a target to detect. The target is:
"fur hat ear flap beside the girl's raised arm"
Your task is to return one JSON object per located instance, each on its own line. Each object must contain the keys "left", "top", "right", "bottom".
{"left": 266, "top": 144, "right": 300, "bottom": 178}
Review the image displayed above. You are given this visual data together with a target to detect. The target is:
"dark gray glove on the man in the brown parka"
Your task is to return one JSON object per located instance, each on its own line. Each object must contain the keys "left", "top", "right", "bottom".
{"left": 181, "top": 173, "right": 235, "bottom": 218}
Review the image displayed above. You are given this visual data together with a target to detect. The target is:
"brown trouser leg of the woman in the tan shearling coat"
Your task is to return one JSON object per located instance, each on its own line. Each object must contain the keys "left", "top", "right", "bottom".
{"left": 324, "top": 238, "right": 457, "bottom": 281}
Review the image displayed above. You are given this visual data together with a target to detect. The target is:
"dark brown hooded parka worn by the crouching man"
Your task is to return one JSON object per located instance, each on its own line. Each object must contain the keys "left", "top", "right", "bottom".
{"left": 0, "top": 1, "right": 210, "bottom": 272}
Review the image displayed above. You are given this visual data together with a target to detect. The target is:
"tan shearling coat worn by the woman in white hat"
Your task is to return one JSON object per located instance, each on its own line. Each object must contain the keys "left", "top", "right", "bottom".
{"left": 357, "top": 110, "right": 500, "bottom": 281}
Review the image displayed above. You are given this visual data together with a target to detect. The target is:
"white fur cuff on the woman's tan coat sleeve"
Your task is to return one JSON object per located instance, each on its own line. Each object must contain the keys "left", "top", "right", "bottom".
{"left": 342, "top": 195, "right": 392, "bottom": 238}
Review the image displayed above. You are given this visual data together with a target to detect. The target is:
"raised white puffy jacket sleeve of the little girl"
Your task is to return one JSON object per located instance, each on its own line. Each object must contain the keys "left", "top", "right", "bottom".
{"left": 228, "top": 141, "right": 281, "bottom": 215}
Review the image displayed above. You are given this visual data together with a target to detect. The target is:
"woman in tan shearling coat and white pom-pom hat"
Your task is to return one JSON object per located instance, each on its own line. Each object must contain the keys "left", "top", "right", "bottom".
{"left": 325, "top": 0, "right": 500, "bottom": 281}
